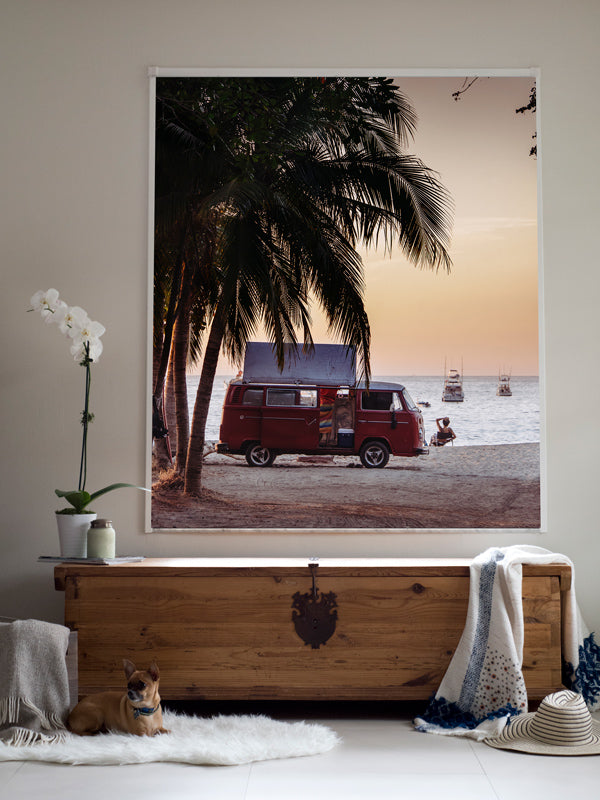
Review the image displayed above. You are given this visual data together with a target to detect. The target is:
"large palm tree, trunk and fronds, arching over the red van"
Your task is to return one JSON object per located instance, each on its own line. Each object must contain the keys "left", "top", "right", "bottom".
{"left": 152, "top": 78, "right": 450, "bottom": 494}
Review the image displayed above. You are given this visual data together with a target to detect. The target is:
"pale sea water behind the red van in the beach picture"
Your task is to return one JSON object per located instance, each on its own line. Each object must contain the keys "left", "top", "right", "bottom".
{"left": 188, "top": 375, "right": 540, "bottom": 447}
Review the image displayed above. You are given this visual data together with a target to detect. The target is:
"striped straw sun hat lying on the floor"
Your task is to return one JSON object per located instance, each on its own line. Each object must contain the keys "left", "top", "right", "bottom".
{"left": 484, "top": 689, "right": 600, "bottom": 756}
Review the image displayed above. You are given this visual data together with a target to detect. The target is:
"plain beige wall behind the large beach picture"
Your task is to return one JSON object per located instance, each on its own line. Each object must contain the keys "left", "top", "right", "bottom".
{"left": 0, "top": 0, "right": 600, "bottom": 627}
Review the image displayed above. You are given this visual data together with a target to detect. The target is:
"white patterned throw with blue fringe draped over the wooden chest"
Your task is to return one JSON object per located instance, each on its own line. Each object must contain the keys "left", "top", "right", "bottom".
{"left": 415, "top": 545, "right": 600, "bottom": 739}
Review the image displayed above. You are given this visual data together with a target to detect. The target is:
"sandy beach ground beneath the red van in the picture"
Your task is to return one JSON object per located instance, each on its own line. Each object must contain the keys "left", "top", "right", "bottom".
{"left": 152, "top": 444, "right": 540, "bottom": 530}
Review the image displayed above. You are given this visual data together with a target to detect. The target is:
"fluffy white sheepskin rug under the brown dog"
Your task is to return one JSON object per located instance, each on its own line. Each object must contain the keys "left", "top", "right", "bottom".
{"left": 0, "top": 711, "right": 340, "bottom": 766}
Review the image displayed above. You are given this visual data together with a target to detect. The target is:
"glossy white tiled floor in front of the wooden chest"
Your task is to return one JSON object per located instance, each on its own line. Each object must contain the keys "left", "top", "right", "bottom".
{"left": 0, "top": 707, "right": 600, "bottom": 800}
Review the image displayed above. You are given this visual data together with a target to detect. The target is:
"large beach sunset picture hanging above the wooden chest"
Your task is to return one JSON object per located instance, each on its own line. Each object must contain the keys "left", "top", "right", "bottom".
{"left": 149, "top": 75, "right": 542, "bottom": 532}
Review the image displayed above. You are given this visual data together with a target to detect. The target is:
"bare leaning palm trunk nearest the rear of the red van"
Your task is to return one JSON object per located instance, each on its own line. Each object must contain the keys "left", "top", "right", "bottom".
{"left": 184, "top": 303, "right": 225, "bottom": 496}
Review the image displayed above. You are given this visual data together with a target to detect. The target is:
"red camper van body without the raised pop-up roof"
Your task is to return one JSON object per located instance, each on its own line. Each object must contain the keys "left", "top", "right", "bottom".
{"left": 217, "top": 381, "right": 429, "bottom": 468}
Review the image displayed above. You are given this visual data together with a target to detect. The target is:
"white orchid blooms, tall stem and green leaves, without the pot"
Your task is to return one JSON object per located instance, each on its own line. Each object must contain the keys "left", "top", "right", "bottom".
{"left": 29, "top": 289, "right": 149, "bottom": 514}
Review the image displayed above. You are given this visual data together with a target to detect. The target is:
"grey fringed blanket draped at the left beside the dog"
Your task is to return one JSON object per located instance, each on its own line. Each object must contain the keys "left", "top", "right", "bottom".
{"left": 0, "top": 619, "right": 69, "bottom": 745}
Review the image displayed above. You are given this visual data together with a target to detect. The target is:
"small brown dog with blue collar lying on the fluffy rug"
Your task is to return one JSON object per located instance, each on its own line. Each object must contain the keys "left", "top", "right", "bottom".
{"left": 67, "top": 658, "right": 169, "bottom": 736}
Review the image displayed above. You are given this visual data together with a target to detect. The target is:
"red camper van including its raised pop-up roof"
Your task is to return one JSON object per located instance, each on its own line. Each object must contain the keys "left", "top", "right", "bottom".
{"left": 217, "top": 342, "right": 429, "bottom": 468}
